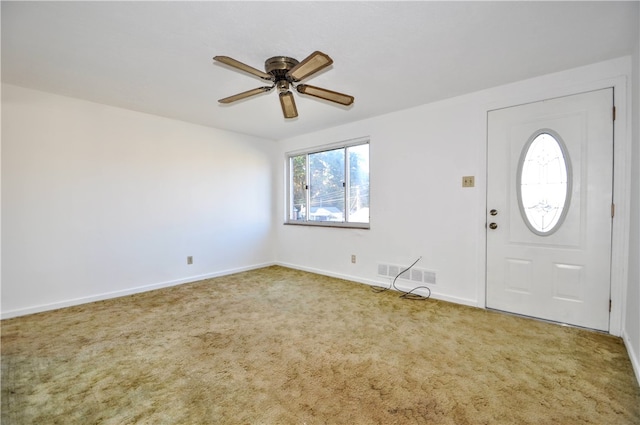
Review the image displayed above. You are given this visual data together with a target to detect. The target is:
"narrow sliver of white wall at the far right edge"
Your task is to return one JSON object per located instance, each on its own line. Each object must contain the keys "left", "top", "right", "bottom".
{"left": 623, "top": 8, "right": 640, "bottom": 382}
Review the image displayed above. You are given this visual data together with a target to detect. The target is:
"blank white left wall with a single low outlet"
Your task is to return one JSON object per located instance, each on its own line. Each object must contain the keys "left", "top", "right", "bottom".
{"left": 2, "top": 85, "right": 275, "bottom": 318}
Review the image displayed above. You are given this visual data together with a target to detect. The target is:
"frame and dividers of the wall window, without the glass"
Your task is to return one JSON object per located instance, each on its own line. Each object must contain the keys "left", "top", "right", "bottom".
{"left": 284, "top": 137, "right": 371, "bottom": 229}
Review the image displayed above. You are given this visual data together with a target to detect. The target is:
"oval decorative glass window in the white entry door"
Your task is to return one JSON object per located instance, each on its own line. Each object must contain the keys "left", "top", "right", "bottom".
{"left": 516, "top": 129, "right": 571, "bottom": 236}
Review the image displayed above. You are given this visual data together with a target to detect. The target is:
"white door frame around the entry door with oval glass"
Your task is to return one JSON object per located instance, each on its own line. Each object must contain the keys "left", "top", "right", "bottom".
{"left": 476, "top": 68, "right": 631, "bottom": 336}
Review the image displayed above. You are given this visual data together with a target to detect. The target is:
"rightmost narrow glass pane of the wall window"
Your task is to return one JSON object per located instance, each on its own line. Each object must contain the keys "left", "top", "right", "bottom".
{"left": 347, "top": 144, "right": 369, "bottom": 223}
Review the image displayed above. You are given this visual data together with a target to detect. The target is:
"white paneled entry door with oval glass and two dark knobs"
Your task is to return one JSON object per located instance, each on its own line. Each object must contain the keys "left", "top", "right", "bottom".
{"left": 486, "top": 89, "right": 614, "bottom": 331}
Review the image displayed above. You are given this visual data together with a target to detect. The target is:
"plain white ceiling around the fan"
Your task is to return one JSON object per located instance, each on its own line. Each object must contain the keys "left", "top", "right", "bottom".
{"left": 1, "top": 1, "right": 639, "bottom": 139}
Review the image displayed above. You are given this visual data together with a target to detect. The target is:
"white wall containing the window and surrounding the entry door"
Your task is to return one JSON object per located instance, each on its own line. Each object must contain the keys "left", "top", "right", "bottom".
{"left": 276, "top": 57, "right": 631, "bottom": 335}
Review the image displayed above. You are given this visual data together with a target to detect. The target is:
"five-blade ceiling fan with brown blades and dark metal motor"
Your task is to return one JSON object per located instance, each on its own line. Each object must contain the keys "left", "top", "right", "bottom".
{"left": 213, "top": 51, "right": 354, "bottom": 118}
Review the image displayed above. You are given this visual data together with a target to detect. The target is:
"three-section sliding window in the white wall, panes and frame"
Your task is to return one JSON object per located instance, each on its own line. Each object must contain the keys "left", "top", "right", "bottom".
{"left": 287, "top": 140, "right": 369, "bottom": 228}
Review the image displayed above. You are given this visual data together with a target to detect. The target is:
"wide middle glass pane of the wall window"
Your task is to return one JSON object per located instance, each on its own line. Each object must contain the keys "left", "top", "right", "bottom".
{"left": 309, "top": 148, "right": 345, "bottom": 221}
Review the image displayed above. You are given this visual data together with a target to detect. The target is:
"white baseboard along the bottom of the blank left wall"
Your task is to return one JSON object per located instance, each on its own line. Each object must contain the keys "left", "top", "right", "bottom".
{"left": 0, "top": 262, "right": 275, "bottom": 320}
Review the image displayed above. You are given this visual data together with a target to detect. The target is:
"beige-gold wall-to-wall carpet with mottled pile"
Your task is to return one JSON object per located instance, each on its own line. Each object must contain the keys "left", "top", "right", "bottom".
{"left": 1, "top": 267, "right": 640, "bottom": 425}
